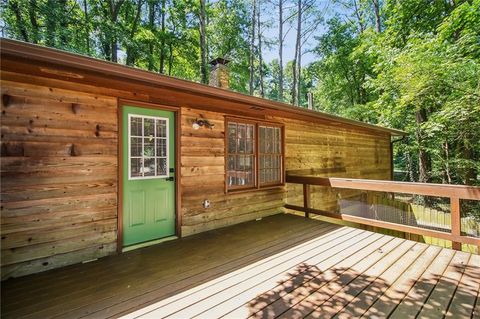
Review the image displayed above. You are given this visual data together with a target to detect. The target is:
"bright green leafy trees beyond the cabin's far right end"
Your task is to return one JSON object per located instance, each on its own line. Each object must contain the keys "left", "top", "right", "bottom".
{"left": 310, "top": 0, "right": 480, "bottom": 185}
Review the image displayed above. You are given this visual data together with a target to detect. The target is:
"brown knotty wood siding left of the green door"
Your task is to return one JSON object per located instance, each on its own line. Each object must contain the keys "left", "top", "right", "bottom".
{"left": 1, "top": 80, "right": 118, "bottom": 279}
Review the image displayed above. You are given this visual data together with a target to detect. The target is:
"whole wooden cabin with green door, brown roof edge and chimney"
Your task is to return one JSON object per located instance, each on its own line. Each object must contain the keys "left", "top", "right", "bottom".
{"left": 0, "top": 39, "right": 404, "bottom": 279}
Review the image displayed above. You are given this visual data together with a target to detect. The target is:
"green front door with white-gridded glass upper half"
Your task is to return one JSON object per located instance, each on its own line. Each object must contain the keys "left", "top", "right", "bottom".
{"left": 122, "top": 106, "right": 175, "bottom": 247}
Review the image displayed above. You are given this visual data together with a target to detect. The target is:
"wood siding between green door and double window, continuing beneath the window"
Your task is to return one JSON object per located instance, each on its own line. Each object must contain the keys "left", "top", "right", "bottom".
{"left": 181, "top": 107, "right": 285, "bottom": 236}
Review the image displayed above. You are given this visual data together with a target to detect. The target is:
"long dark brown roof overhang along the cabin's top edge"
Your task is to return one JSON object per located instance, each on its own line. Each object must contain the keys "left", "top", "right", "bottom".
{"left": 0, "top": 38, "right": 407, "bottom": 136}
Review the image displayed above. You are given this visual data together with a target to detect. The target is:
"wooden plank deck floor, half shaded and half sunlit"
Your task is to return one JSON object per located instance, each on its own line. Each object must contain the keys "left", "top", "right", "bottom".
{"left": 2, "top": 215, "right": 480, "bottom": 318}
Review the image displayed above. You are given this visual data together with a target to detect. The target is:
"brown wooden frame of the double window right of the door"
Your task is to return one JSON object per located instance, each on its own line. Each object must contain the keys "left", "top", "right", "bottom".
{"left": 224, "top": 116, "right": 285, "bottom": 194}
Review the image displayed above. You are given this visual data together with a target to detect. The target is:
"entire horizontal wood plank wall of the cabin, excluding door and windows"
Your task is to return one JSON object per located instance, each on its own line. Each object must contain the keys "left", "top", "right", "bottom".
{"left": 1, "top": 71, "right": 390, "bottom": 278}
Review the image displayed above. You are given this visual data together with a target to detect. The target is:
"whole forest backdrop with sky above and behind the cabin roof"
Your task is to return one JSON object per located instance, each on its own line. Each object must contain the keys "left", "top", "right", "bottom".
{"left": 0, "top": 0, "right": 480, "bottom": 185}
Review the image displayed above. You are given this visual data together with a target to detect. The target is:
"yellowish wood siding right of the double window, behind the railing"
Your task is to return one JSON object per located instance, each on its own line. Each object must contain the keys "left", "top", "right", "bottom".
{"left": 284, "top": 119, "right": 391, "bottom": 211}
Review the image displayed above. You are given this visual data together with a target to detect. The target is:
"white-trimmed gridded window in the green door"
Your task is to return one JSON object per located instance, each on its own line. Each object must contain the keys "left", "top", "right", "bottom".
{"left": 128, "top": 114, "right": 169, "bottom": 179}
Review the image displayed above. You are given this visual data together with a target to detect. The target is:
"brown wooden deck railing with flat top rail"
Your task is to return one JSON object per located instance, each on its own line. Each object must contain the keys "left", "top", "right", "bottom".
{"left": 285, "top": 175, "right": 480, "bottom": 250}
